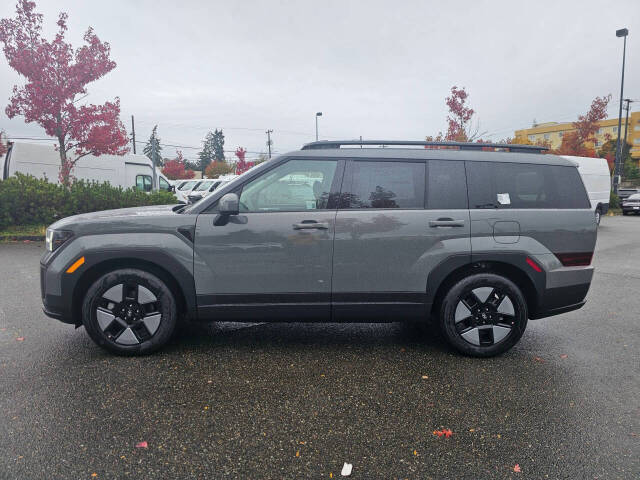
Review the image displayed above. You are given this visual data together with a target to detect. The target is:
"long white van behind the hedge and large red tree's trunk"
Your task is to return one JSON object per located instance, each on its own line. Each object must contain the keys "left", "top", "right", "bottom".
{"left": 0, "top": 142, "right": 173, "bottom": 192}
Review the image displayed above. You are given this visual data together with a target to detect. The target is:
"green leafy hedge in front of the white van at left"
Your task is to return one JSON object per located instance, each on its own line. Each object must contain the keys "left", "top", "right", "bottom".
{"left": 0, "top": 173, "right": 177, "bottom": 229}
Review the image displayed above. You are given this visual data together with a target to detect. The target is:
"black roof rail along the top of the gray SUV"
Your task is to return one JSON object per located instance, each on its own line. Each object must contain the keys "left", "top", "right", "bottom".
{"left": 302, "top": 140, "right": 549, "bottom": 153}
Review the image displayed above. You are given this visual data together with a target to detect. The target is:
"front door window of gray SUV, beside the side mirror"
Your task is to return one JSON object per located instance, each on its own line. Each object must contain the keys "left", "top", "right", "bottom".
{"left": 240, "top": 160, "right": 338, "bottom": 212}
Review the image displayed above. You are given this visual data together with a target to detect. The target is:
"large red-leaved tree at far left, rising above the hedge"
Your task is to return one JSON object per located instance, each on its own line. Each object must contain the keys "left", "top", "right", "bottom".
{"left": 0, "top": 0, "right": 128, "bottom": 185}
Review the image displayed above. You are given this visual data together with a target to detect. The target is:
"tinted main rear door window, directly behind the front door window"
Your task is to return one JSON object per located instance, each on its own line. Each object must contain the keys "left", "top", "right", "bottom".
{"left": 340, "top": 160, "right": 425, "bottom": 209}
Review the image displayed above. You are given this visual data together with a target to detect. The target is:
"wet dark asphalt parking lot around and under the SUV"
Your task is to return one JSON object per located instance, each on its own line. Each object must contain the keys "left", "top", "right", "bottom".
{"left": 0, "top": 217, "right": 640, "bottom": 479}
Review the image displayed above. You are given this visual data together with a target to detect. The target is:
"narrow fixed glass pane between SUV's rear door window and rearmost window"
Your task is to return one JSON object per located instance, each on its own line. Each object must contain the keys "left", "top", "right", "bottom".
{"left": 427, "top": 160, "right": 467, "bottom": 210}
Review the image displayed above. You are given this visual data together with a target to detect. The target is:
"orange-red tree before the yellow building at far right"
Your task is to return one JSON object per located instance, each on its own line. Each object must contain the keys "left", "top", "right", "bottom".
{"left": 552, "top": 94, "right": 611, "bottom": 157}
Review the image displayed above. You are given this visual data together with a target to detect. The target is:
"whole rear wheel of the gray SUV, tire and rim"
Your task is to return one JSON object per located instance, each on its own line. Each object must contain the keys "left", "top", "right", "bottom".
{"left": 440, "top": 273, "right": 528, "bottom": 357}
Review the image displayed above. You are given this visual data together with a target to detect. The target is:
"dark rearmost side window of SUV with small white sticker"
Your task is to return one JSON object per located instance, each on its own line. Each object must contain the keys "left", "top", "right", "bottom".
{"left": 466, "top": 162, "right": 590, "bottom": 209}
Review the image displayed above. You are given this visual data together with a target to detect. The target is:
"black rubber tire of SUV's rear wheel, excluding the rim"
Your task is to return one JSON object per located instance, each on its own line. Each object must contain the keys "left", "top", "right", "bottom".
{"left": 440, "top": 273, "right": 527, "bottom": 357}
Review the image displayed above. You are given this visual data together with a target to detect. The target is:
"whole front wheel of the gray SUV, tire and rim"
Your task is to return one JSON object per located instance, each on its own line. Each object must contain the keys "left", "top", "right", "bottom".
{"left": 82, "top": 269, "right": 177, "bottom": 356}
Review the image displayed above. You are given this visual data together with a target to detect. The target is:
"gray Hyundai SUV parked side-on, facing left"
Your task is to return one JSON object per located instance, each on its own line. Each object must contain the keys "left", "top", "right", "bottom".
{"left": 40, "top": 141, "right": 597, "bottom": 357}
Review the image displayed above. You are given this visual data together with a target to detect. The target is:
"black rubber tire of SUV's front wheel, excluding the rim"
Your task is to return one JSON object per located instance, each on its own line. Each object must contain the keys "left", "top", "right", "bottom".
{"left": 82, "top": 269, "right": 177, "bottom": 356}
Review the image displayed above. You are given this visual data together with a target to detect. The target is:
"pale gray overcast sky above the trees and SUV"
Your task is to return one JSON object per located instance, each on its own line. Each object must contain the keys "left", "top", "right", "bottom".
{"left": 0, "top": 0, "right": 640, "bottom": 158}
